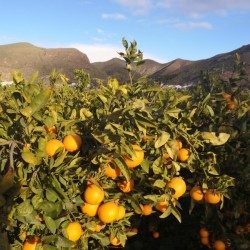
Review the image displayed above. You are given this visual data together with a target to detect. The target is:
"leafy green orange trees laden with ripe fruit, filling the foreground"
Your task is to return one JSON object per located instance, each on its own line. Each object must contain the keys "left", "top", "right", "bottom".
{"left": 0, "top": 39, "right": 250, "bottom": 250}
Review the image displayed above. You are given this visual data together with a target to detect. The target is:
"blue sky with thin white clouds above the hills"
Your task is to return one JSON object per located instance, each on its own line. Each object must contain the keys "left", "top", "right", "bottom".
{"left": 0, "top": 0, "right": 250, "bottom": 63}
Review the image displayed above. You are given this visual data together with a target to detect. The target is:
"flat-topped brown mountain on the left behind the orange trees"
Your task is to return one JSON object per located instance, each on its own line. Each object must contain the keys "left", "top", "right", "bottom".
{"left": 0, "top": 43, "right": 107, "bottom": 81}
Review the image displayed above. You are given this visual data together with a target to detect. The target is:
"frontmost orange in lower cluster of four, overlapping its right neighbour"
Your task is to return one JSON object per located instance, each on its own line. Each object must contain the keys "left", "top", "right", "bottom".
{"left": 97, "top": 201, "right": 119, "bottom": 223}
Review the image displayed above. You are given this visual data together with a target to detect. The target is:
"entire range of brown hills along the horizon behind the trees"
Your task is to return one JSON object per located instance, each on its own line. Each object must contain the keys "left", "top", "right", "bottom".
{"left": 0, "top": 43, "right": 250, "bottom": 84}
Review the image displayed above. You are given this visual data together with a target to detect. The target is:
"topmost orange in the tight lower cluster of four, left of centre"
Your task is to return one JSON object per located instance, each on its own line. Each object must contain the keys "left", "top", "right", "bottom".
{"left": 83, "top": 184, "right": 104, "bottom": 205}
